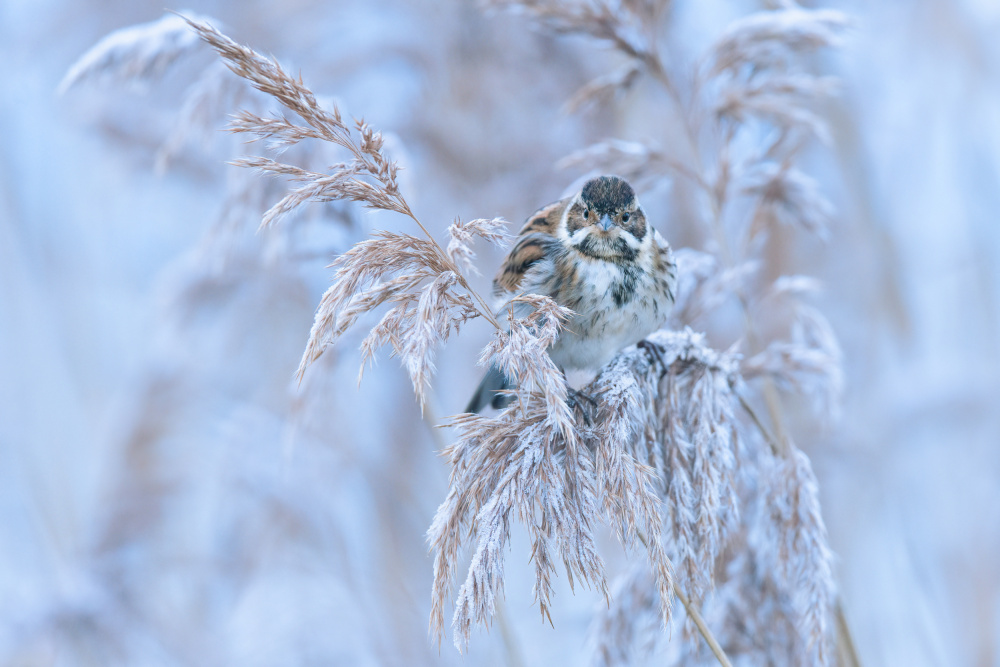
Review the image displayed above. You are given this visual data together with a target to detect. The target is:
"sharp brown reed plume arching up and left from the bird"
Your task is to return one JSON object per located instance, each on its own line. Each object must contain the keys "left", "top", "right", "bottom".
{"left": 178, "top": 21, "right": 505, "bottom": 404}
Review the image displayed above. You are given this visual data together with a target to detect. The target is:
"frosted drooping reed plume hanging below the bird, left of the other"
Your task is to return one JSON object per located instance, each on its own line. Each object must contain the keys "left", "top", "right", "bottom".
{"left": 428, "top": 302, "right": 584, "bottom": 650}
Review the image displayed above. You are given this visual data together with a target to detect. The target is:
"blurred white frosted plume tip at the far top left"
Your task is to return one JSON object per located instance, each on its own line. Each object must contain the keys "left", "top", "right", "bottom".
{"left": 59, "top": 13, "right": 211, "bottom": 93}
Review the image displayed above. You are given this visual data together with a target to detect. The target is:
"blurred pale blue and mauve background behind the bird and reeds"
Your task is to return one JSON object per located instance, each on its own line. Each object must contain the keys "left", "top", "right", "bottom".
{"left": 0, "top": 0, "right": 1000, "bottom": 667}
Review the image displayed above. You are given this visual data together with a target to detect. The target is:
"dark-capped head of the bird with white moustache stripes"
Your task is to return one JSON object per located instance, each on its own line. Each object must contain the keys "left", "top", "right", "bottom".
{"left": 566, "top": 176, "right": 648, "bottom": 260}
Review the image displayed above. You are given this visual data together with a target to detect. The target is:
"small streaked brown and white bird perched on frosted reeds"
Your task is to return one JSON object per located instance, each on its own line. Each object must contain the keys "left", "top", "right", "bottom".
{"left": 466, "top": 176, "right": 677, "bottom": 412}
